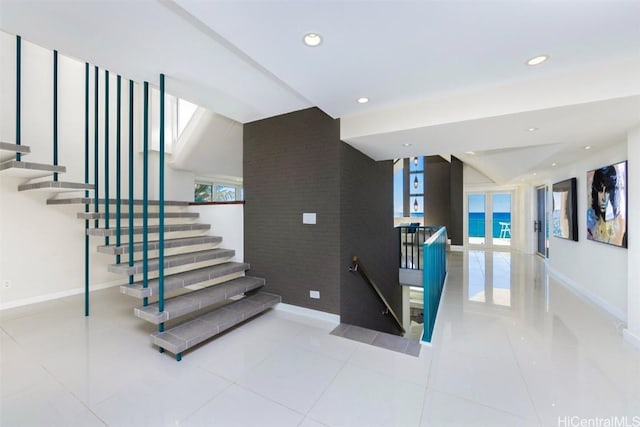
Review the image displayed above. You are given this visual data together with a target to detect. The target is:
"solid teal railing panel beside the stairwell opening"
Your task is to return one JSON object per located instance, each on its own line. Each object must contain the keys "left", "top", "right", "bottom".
{"left": 422, "top": 227, "right": 447, "bottom": 342}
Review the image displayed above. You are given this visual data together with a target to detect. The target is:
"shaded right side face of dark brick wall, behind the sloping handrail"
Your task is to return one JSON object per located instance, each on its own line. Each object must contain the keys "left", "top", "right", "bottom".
{"left": 340, "top": 144, "right": 402, "bottom": 334}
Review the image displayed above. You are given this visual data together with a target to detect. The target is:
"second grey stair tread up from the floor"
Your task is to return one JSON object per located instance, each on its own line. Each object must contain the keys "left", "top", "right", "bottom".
{"left": 133, "top": 276, "right": 265, "bottom": 325}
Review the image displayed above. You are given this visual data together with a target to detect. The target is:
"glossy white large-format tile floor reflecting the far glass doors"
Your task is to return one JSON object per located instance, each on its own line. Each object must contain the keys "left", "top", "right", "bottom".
{"left": 0, "top": 251, "right": 640, "bottom": 427}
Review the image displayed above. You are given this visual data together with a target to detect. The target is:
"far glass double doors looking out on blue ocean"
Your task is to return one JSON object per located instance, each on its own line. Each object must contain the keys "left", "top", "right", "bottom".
{"left": 467, "top": 191, "right": 513, "bottom": 247}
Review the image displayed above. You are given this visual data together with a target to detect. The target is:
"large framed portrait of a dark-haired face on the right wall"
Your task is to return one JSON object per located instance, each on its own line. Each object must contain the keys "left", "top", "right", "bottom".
{"left": 587, "top": 161, "right": 627, "bottom": 248}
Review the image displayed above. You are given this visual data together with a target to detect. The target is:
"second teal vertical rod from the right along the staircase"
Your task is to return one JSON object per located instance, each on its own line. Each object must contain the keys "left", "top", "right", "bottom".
{"left": 142, "top": 82, "right": 149, "bottom": 307}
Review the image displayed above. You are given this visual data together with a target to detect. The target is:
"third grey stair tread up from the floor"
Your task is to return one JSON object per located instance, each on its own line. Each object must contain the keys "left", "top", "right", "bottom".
{"left": 120, "top": 262, "right": 250, "bottom": 298}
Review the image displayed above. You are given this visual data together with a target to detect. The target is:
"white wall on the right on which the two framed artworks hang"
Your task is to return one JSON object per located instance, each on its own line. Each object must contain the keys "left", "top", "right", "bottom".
{"left": 547, "top": 141, "right": 640, "bottom": 320}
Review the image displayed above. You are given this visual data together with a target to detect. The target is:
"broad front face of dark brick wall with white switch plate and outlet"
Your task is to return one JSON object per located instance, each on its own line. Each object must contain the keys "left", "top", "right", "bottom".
{"left": 243, "top": 108, "right": 347, "bottom": 314}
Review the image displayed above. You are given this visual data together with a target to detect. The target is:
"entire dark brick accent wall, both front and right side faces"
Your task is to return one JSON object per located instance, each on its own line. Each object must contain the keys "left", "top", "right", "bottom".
{"left": 243, "top": 108, "right": 402, "bottom": 333}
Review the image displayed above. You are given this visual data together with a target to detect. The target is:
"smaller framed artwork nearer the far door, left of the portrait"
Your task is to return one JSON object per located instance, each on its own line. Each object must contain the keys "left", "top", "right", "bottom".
{"left": 552, "top": 178, "right": 578, "bottom": 242}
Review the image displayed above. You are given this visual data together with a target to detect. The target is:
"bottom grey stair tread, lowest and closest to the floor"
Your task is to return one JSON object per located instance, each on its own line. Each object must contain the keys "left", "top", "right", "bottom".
{"left": 151, "top": 292, "right": 282, "bottom": 360}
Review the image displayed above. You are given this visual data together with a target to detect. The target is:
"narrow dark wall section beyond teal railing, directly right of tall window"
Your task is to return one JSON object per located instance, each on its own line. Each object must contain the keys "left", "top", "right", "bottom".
{"left": 424, "top": 156, "right": 451, "bottom": 229}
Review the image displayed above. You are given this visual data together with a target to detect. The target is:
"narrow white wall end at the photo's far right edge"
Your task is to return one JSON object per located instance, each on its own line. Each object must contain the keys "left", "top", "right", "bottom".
{"left": 624, "top": 127, "right": 640, "bottom": 347}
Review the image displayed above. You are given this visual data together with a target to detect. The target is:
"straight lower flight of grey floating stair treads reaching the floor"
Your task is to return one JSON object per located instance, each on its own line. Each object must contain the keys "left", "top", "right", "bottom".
{"left": 57, "top": 197, "right": 281, "bottom": 361}
